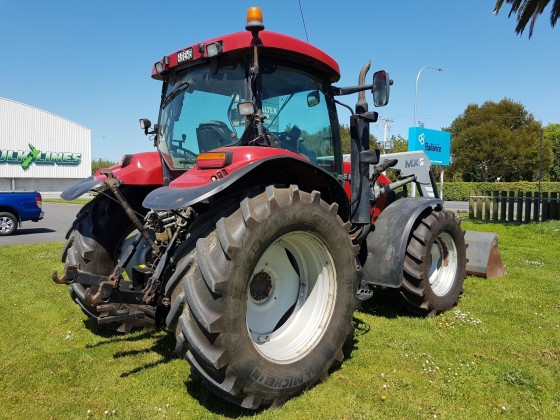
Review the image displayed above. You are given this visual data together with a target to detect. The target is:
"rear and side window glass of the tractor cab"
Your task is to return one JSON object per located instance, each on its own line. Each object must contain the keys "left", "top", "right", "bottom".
{"left": 157, "top": 60, "right": 335, "bottom": 172}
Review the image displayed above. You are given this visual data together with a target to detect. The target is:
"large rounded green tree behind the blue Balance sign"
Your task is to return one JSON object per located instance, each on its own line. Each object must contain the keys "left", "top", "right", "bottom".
{"left": 449, "top": 99, "right": 552, "bottom": 181}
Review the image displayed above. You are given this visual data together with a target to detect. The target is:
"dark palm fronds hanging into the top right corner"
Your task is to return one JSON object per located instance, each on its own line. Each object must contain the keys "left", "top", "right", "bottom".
{"left": 494, "top": 0, "right": 560, "bottom": 38}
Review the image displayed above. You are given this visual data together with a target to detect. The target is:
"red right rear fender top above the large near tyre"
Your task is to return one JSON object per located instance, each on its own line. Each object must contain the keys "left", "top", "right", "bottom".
{"left": 169, "top": 146, "right": 309, "bottom": 188}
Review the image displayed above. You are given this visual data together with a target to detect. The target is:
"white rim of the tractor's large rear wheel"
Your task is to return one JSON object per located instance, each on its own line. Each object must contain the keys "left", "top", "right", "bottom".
{"left": 246, "top": 232, "right": 336, "bottom": 363}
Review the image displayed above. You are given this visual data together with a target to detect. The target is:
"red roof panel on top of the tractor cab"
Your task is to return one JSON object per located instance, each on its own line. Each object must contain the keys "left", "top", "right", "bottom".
{"left": 152, "top": 31, "right": 340, "bottom": 83}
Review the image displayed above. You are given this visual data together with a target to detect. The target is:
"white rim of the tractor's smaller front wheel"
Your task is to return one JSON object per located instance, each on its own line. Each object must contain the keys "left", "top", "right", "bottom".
{"left": 428, "top": 232, "right": 457, "bottom": 296}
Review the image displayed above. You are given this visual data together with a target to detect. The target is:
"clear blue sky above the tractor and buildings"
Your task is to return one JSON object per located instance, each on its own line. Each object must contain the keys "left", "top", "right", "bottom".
{"left": 0, "top": 0, "right": 560, "bottom": 161}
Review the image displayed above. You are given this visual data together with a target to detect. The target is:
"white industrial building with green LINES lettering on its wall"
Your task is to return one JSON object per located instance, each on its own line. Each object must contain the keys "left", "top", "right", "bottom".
{"left": 0, "top": 98, "right": 91, "bottom": 193}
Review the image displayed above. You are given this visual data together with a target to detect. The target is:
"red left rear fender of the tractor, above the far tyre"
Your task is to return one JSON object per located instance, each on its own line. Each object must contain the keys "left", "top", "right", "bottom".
{"left": 95, "top": 152, "right": 163, "bottom": 185}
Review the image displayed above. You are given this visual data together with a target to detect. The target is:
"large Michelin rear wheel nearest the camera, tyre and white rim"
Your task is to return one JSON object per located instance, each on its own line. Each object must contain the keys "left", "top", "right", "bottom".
{"left": 167, "top": 186, "right": 360, "bottom": 409}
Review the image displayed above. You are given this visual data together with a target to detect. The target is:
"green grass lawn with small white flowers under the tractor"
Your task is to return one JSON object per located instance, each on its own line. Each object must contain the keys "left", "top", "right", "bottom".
{"left": 0, "top": 221, "right": 560, "bottom": 419}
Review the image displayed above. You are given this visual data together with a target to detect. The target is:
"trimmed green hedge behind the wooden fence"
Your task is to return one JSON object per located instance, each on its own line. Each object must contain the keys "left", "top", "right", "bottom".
{"left": 437, "top": 181, "right": 560, "bottom": 201}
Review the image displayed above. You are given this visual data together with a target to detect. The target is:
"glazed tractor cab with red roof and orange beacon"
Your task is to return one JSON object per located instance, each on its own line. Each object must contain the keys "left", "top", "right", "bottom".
{"left": 140, "top": 6, "right": 390, "bottom": 187}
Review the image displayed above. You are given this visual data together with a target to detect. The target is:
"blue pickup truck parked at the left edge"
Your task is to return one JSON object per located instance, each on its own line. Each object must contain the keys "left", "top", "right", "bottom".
{"left": 0, "top": 191, "right": 44, "bottom": 236}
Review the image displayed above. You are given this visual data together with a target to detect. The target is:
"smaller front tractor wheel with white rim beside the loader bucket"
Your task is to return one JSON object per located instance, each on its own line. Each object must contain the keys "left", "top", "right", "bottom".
{"left": 401, "top": 210, "right": 466, "bottom": 316}
